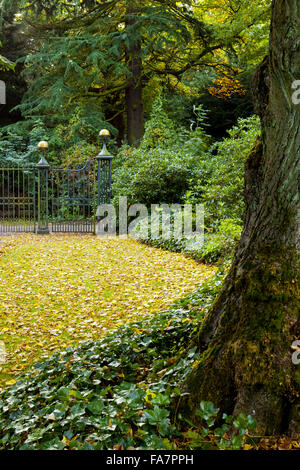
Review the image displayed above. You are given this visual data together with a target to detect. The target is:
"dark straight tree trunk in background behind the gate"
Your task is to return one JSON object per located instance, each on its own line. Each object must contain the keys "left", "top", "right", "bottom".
{"left": 126, "top": 0, "right": 144, "bottom": 145}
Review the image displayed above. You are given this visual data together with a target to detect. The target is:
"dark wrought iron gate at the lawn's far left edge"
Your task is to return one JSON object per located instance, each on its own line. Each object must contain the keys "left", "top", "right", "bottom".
{"left": 0, "top": 149, "right": 112, "bottom": 234}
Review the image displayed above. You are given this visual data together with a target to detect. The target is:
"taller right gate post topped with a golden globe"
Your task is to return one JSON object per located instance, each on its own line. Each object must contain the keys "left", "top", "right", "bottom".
{"left": 96, "top": 129, "right": 114, "bottom": 209}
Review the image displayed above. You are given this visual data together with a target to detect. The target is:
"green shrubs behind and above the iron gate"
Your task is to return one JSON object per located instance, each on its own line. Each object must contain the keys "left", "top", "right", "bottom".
{"left": 0, "top": 110, "right": 112, "bottom": 167}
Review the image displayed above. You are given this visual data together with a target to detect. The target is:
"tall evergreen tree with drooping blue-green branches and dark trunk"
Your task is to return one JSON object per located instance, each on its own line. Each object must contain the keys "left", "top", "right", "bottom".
{"left": 5, "top": 0, "right": 267, "bottom": 144}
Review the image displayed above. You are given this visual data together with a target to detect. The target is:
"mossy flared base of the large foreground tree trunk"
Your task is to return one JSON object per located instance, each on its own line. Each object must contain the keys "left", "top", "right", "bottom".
{"left": 181, "top": 247, "right": 300, "bottom": 434}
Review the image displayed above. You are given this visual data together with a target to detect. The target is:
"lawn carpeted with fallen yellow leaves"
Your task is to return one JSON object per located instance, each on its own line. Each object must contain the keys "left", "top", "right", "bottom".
{"left": 0, "top": 234, "right": 215, "bottom": 387}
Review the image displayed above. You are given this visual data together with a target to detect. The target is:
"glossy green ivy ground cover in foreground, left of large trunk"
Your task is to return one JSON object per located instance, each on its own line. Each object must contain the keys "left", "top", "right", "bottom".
{"left": 0, "top": 276, "right": 221, "bottom": 450}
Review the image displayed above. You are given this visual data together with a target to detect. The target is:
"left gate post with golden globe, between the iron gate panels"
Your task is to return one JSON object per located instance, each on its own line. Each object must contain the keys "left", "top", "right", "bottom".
{"left": 36, "top": 141, "right": 50, "bottom": 235}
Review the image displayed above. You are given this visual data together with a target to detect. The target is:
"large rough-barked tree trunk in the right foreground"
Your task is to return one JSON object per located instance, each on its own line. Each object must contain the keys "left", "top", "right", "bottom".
{"left": 178, "top": 0, "right": 300, "bottom": 435}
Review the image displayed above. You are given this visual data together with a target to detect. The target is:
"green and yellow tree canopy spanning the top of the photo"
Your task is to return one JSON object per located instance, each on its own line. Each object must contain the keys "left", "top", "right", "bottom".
{"left": 2, "top": 0, "right": 270, "bottom": 143}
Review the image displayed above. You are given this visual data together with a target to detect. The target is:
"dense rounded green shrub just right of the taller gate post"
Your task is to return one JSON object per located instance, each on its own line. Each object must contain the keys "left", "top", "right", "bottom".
{"left": 113, "top": 97, "right": 209, "bottom": 206}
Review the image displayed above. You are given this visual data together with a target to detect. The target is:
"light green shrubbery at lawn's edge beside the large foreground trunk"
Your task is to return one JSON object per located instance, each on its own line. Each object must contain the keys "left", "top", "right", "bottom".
{"left": 139, "top": 116, "right": 260, "bottom": 264}
